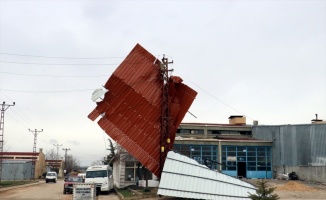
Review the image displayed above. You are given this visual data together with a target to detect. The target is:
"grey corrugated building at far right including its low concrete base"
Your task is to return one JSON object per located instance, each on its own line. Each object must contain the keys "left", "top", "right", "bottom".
{"left": 252, "top": 121, "right": 326, "bottom": 183}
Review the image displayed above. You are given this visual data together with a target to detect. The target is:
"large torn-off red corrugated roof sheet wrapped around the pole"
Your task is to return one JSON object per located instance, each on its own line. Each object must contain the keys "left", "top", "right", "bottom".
{"left": 88, "top": 44, "right": 197, "bottom": 176}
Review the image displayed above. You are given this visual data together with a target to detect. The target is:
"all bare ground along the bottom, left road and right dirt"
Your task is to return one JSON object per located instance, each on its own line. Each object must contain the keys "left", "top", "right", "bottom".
{"left": 0, "top": 179, "right": 326, "bottom": 200}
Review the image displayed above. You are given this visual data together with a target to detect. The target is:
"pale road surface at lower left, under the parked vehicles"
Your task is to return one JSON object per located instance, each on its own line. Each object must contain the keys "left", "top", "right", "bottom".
{"left": 0, "top": 180, "right": 119, "bottom": 200}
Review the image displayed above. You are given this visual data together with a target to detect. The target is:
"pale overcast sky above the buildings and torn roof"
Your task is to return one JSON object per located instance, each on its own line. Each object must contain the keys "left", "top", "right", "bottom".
{"left": 0, "top": 0, "right": 326, "bottom": 165}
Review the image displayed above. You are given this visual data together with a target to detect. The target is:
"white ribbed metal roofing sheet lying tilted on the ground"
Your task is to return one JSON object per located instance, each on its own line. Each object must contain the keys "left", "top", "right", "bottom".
{"left": 157, "top": 151, "right": 256, "bottom": 200}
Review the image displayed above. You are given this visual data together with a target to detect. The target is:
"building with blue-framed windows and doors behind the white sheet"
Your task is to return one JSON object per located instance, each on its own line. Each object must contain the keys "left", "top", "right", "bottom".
{"left": 173, "top": 116, "right": 273, "bottom": 178}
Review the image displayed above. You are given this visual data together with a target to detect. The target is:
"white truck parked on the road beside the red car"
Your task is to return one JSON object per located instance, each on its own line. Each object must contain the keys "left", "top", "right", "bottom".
{"left": 85, "top": 165, "right": 113, "bottom": 195}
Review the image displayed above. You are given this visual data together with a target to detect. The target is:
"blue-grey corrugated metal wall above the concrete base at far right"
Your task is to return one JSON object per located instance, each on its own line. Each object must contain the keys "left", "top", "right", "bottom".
{"left": 252, "top": 124, "right": 326, "bottom": 167}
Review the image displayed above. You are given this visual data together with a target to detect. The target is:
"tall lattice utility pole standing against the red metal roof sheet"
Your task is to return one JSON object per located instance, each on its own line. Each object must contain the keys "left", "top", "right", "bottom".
{"left": 160, "top": 55, "right": 173, "bottom": 176}
